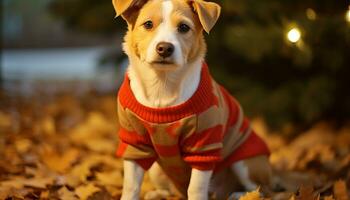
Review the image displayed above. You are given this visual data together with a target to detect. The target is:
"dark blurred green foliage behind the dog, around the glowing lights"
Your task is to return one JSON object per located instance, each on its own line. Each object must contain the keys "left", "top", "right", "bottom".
{"left": 52, "top": 0, "right": 350, "bottom": 130}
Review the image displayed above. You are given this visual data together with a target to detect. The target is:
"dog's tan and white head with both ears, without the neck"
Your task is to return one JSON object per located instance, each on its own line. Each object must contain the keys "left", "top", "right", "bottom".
{"left": 112, "top": 0, "right": 220, "bottom": 70}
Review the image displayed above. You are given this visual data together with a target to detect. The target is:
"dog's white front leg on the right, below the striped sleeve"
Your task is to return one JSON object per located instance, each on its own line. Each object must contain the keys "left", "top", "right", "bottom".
{"left": 187, "top": 169, "right": 213, "bottom": 200}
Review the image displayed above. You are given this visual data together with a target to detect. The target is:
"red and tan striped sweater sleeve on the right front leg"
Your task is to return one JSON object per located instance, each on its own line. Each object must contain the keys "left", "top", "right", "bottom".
{"left": 181, "top": 125, "right": 223, "bottom": 170}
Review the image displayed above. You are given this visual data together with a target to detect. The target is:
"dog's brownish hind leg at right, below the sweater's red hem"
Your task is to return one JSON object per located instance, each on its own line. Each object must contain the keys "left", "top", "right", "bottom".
{"left": 231, "top": 156, "right": 272, "bottom": 193}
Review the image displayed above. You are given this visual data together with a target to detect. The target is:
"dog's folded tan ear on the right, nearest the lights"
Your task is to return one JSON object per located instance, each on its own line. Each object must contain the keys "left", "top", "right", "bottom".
{"left": 189, "top": 0, "right": 221, "bottom": 33}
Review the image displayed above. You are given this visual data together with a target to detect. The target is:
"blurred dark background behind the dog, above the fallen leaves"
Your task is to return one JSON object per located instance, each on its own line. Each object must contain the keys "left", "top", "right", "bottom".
{"left": 0, "top": 0, "right": 350, "bottom": 132}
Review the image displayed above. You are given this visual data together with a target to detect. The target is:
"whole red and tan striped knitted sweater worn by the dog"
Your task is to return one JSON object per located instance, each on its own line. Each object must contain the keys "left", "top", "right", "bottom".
{"left": 117, "top": 64, "right": 269, "bottom": 196}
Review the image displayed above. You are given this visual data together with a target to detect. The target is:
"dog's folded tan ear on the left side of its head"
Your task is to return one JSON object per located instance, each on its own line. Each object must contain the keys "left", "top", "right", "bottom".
{"left": 112, "top": 0, "right": 147, "bottom": 25}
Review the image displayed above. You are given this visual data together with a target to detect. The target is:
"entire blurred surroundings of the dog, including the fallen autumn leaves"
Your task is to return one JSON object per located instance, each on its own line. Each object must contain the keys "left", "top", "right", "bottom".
{"left": 0, "top": 0, "right": 350, "bottom": 200}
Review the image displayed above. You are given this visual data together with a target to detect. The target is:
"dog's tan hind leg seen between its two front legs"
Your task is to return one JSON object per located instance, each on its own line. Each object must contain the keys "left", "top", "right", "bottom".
{"left": 144, "top": 163, "right": 172, "bottom": 200}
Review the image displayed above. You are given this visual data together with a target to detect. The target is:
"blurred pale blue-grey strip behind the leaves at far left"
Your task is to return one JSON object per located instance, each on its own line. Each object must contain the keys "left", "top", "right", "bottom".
{"left": 1, "top": 47, "right": 114, "bottom": 80}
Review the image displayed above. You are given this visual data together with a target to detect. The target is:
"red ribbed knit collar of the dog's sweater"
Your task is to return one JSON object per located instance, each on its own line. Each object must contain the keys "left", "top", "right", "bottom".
{"left": 118, "top": 63, "right": 215, "bottom": 123}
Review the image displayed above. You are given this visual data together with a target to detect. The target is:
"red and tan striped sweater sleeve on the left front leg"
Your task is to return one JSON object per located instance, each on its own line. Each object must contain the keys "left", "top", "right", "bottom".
{"left": 116, "top": 101, "right": 157, "bottom": 170}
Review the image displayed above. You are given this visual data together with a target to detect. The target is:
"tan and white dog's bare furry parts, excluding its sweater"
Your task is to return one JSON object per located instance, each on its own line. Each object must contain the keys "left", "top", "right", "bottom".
{"left": 112, "top": 0, "right": 271, "bottom": 200}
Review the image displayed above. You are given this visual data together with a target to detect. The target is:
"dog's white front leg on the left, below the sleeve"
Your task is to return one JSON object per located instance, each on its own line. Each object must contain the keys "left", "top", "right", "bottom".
{"left": 121, "top": 160, "right": 145, "bottom": 200}
